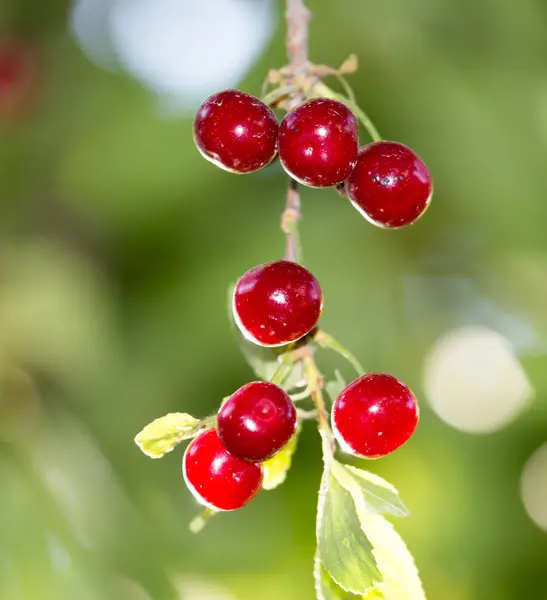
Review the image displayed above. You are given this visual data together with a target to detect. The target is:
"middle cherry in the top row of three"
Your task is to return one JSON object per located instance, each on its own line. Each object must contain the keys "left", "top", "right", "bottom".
{"left": 279, "top": 98, "right": 359, "bottom": 187}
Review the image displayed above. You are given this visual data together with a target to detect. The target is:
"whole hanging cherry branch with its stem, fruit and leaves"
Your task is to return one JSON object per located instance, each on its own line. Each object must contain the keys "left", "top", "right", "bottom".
{"left": 135, "top": 0, "right": 433, "bottom": 600}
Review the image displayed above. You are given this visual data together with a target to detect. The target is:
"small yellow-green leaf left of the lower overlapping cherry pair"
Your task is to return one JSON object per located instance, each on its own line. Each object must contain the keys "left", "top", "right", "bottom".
{"left": 135, "top": 413, "right": 202, "bottom": 458}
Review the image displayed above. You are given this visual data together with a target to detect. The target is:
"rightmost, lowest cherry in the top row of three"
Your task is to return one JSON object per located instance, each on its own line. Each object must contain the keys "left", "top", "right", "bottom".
{"left": 346, "top": 142, "right": 433, "bottom": 229}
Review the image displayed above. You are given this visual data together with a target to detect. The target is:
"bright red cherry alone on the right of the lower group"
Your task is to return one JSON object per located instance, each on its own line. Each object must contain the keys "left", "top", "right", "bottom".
{"left": 332, "top": 373, "right": 419, "bottom": 458}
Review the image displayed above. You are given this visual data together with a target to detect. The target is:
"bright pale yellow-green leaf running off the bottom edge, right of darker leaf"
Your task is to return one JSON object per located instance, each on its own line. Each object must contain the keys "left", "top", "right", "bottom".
{"left": 358, "top": 509, "right": 425, "bottom": 600}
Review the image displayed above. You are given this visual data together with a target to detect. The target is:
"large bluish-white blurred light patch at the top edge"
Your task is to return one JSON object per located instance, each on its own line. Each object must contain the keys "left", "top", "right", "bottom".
{"left": 71, "top": 0, "right": 275, "bottom": 112}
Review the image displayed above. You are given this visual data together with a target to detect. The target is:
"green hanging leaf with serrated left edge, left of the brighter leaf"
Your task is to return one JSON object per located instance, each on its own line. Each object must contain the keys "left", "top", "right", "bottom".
{"left": 317, "top": 466, "right": 382, "bottom": 594}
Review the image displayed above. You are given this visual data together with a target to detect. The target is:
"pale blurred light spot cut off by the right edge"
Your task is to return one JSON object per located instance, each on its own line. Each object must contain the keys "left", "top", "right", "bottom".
{"left": 520, "top": 443, "right": 547, "bottom": 531}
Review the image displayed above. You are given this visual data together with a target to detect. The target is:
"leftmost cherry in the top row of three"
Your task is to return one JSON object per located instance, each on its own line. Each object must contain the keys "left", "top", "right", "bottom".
{"left": 194, "top": 90, "right": 279, "bottom": 173}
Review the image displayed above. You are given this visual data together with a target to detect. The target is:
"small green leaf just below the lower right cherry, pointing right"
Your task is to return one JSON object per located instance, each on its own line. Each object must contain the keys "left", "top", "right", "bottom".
{"left": 331, "top": 461, "right": 410, "bottom": 517}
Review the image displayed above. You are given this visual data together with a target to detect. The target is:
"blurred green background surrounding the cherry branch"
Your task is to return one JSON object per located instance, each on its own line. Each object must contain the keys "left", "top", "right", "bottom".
{"left": 0, "top": 0, "right": 547, "bottom": 600}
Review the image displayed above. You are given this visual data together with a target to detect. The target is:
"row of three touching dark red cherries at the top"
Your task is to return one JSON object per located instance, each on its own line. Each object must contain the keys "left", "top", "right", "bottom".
{"left": 194, "top": 90, "right": 433, "bottom": 229}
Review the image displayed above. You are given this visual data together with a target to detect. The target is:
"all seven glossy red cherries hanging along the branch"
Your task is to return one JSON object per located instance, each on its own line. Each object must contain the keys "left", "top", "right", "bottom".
{"left": 183, "top": 90, "right": 432, "bottom": 510}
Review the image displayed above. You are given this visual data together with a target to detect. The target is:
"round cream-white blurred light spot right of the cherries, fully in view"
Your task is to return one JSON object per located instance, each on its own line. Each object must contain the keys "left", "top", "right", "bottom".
{"left": 423, "top": 327, "right": 533, "bottom": 433}
